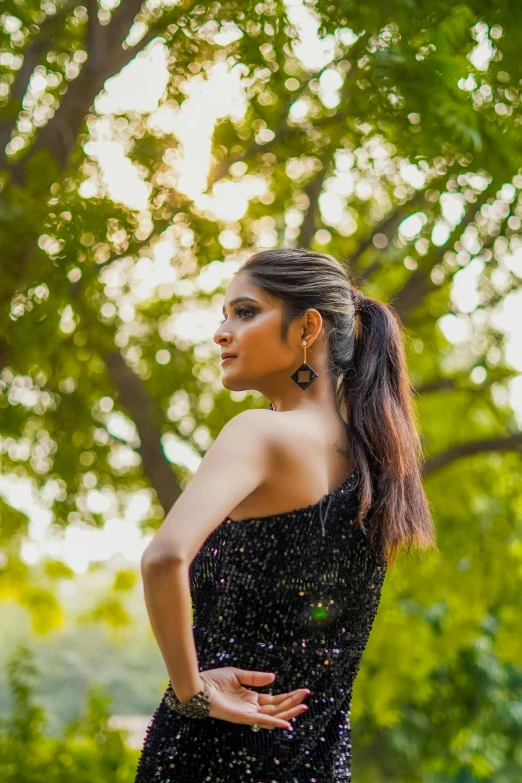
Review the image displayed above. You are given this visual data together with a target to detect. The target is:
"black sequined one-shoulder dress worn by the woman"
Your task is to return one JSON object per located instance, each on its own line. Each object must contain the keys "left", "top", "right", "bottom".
{"left": 134, "top": 426, "right": 387, "bottom": 783}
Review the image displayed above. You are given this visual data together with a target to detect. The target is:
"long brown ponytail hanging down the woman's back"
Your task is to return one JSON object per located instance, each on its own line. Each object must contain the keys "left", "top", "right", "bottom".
{"left": 338, "top": 288, "right": 436, "bottom": 564}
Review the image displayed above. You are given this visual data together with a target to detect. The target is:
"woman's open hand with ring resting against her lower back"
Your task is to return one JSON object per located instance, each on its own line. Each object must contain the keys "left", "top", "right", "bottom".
{"left": 199, "top": 666, "right": 311, "bottom": 730}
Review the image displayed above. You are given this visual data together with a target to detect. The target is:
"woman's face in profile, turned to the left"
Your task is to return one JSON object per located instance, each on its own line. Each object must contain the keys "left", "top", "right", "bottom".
{"left": 214, "top": 273, "right": 303, "bottom": 394}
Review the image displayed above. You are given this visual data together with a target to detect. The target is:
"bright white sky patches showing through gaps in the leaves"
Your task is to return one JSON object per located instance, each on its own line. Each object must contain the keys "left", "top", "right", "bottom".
{"left": 5, "top": 0, "right": 522, "bottom": 572}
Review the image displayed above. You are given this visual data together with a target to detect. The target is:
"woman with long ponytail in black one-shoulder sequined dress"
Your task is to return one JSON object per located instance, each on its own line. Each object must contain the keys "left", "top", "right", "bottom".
{"left": 135, "top": 249, "right": 436, "bottom": 783}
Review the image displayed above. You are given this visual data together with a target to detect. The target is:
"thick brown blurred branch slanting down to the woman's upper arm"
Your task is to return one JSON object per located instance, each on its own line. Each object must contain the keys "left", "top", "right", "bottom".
{"left": 105, "top": 351, "right": 181, "bottom": 513}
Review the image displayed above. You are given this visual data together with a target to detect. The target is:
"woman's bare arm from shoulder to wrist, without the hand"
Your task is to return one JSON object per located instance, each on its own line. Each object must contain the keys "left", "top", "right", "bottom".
{"left": 141, "top": 410, "right": 274, "bottom": 701}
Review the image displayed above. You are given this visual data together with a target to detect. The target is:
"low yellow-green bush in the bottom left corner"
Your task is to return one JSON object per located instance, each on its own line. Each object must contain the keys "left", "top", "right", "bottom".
{"left": 0, "top": 647, "right": 137, "bottom": 783}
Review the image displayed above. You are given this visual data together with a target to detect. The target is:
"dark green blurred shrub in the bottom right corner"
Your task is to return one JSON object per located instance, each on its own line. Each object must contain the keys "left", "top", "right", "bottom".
{"left": 352, "top": 632, "right": 522, "bottom": 783}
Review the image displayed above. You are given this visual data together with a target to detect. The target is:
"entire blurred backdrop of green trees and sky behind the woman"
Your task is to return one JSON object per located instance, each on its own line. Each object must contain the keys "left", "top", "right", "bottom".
{"left": 0, "top": 0, "right": 522, "bottom": 783}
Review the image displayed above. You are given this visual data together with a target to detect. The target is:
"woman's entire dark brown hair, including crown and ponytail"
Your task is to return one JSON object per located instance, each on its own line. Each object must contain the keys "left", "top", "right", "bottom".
{"left": 239, "top": 248, "right": 436, "bottom": 564}
